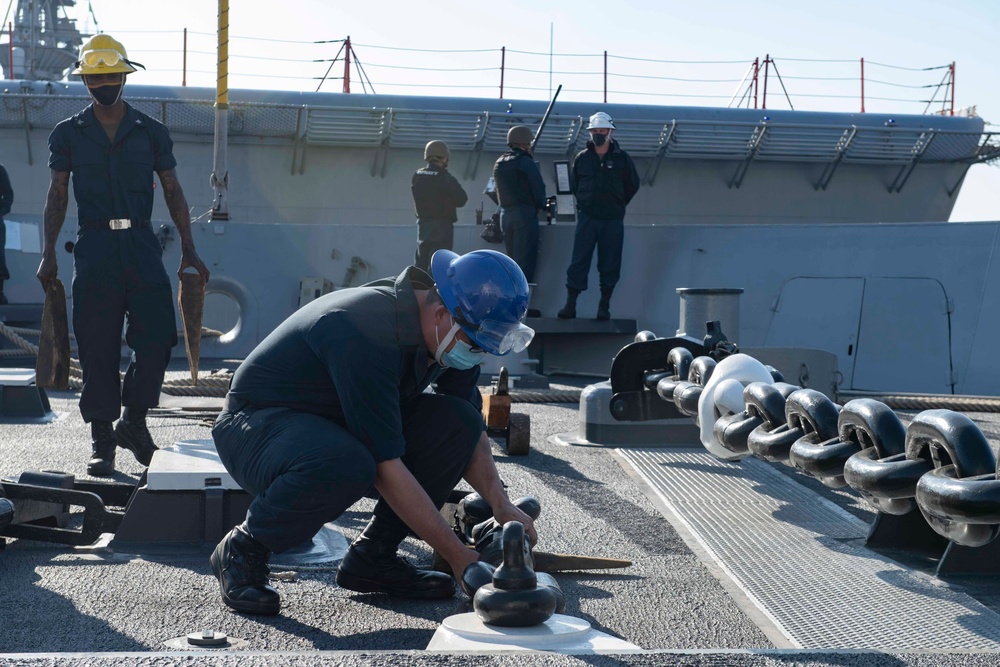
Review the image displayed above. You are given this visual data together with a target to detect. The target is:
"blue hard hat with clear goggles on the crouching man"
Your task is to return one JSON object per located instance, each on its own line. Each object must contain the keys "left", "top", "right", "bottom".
{"left": 431, "top": 250, "right": 535, "bottom": 356}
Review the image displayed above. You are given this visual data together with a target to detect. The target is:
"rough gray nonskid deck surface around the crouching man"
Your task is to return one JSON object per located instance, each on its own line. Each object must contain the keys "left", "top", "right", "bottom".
{"left": 0, "top": 375, "right": 997, "bottom": 667}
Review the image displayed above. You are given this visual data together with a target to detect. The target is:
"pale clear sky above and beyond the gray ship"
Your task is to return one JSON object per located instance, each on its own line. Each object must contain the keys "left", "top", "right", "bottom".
{"left": 13, "top": 0, "right": 1000, "bottom": 221}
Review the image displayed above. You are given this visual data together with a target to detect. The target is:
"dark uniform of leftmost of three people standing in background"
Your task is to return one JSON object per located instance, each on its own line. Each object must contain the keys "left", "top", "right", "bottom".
{"left": 410, "top": 163, "right": 469, "bottom": 271}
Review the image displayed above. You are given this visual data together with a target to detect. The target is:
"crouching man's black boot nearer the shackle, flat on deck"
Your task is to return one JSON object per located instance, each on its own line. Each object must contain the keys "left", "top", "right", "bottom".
{"left": 337, "top": 517, "right": 455, "bottom": 600}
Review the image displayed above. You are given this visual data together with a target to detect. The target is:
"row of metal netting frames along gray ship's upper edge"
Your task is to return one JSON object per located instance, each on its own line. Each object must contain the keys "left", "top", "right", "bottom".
{"left": 0, "top": 91, "right": 1000, "bottom": 179}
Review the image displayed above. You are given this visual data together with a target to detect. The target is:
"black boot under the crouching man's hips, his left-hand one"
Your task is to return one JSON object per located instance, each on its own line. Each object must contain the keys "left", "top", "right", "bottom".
{"left": 208, "top": 524, "right": 281, "bottom": 616}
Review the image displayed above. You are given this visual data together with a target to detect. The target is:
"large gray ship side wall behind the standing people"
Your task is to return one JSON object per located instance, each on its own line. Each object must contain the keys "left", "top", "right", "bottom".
{"left": 0, "top": 81, "right": 1000, "bottom": 394}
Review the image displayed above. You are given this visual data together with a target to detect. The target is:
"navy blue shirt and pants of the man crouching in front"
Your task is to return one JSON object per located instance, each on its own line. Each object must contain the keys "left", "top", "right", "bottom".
{"left": 212, "top": 267, "right": 485, "bottom": 553}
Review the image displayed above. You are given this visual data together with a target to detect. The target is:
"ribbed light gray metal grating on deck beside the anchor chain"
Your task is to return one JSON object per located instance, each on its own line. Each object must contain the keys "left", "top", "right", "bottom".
{"left": 620, "top": 448, "right": 1000, "bottom": 651}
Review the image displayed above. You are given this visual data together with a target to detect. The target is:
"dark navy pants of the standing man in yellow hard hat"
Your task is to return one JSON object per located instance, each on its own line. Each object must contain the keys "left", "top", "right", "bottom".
{"left": 73, "top": 229, "right": 177, "bottom": 422}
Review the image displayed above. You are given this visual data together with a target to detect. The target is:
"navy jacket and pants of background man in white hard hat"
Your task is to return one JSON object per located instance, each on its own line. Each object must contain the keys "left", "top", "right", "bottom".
{"left": 566, "top": 139, "right": 639, "bottom": 292}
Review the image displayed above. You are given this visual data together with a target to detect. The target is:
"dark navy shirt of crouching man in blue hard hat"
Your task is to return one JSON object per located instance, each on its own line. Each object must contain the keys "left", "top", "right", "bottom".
{"left": 229, "top": 267, "right": 482, "bottom": 461}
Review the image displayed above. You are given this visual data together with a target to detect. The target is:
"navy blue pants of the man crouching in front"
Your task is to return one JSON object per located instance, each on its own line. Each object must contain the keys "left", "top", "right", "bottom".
{"left": 212, "top": 394, "right": 483, "bottom": 553}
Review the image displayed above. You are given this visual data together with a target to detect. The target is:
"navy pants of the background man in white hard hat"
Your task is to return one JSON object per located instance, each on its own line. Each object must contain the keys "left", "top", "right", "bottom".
{"left": 566, "top": 211, "right": 625, "bottom": 292}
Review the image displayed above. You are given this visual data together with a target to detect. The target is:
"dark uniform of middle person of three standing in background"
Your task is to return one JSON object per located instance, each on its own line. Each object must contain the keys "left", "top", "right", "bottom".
{"left": 493, "top": 148, "right": 545, "bottom": 283}
